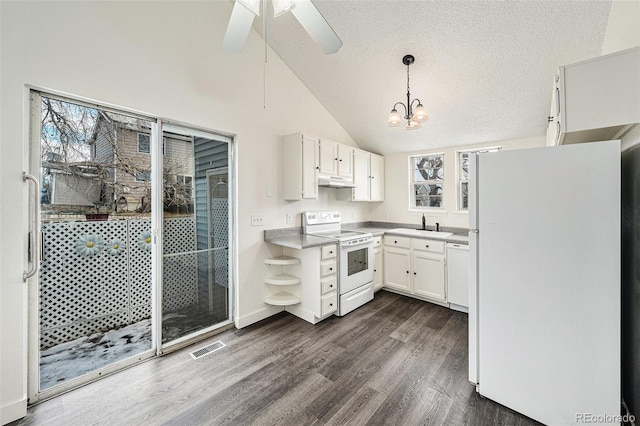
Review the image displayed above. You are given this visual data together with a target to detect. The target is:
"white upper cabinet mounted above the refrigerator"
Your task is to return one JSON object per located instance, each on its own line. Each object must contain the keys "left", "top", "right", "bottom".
{"left": 547, "top": 47, "right": 640, "bottom": 145}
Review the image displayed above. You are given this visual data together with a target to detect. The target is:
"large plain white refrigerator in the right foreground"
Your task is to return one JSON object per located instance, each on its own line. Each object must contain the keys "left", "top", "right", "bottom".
{"left": 469, "top": 141, "right": 621, "bottom": 425}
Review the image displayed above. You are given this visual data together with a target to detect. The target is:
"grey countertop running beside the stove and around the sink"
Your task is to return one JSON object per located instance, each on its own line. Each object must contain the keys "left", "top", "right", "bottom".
{"left": 264, "top": 226, "right": 469, "bottom": 249}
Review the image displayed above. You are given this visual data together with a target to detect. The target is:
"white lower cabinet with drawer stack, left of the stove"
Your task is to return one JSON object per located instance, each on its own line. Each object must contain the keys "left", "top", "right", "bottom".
{"left": 284, "top": 244, "right": 338, "bottom": 324}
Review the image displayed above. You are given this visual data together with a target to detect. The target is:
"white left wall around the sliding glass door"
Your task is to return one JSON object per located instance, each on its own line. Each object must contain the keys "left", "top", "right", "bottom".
{"left": 0, "top": 1, "right": 369, "bottom": 424}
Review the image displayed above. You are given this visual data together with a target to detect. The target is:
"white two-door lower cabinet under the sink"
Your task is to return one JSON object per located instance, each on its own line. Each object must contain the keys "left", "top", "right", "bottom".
{"left": 384, "top": 235, "right": 447, "bottom": 306}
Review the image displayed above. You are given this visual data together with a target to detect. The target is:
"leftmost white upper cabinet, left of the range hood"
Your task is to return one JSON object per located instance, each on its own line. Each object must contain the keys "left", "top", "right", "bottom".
{"left": 283, "top": 133, "right": 320, "bottom": 200}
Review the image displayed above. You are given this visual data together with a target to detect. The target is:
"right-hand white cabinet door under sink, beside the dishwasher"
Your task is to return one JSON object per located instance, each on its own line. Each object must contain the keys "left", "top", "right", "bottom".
{"left": 411, "top": 252, "right": 447, "bottom": 302}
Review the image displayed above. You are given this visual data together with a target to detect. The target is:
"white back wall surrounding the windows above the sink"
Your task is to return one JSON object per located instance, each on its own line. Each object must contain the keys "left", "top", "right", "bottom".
{"left": 371, "top": 136, "right": 546, "bottom": 228}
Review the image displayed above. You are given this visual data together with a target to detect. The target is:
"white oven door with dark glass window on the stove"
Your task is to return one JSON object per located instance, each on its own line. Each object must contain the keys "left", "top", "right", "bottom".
{"left": 338, "top": 241, "right": 373, "bottom": 294}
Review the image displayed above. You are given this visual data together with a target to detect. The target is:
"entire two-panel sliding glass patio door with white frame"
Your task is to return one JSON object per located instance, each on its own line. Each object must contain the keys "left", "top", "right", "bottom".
{"left": 25, "top": 91, "right": 234, "bottom": 403}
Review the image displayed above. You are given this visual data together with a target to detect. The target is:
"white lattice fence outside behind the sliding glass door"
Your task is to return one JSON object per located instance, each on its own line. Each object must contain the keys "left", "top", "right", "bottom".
{"left": 40, "top": 217, "right": 198, "bottom": 349}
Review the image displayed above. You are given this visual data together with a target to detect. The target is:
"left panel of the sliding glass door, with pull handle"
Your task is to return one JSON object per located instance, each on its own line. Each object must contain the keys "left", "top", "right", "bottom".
{"left": 29, "top": 92, "right": 156, "bottom": 397}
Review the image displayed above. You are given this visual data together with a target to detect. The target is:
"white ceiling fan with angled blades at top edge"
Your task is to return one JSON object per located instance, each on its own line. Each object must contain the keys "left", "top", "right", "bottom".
{"left": 222, "top": 0, "right": 342, "bottom": 55}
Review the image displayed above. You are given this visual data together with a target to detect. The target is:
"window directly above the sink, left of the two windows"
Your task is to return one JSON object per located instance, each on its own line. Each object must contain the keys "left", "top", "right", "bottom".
{"left": 409, "top": 153, "right": 444, "bottom": 210}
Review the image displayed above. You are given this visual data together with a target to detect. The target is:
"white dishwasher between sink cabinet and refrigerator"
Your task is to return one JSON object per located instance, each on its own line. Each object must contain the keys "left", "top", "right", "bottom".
{"left": 447, "top": 243, "right": 469, "bottom": 313}
